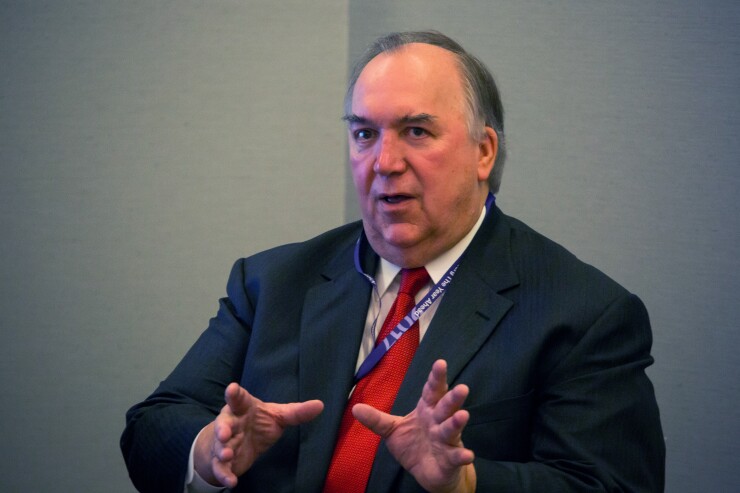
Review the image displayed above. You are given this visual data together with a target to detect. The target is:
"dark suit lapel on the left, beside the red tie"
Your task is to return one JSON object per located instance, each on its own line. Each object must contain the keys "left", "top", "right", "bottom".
{"left": 296, "top": 236, "right": 371, "bottom": 492}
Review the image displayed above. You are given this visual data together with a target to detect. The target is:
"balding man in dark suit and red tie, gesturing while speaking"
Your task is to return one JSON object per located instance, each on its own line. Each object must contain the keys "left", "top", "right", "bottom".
{"left": 121, "top": 32, "right": 664, "bottom": 492}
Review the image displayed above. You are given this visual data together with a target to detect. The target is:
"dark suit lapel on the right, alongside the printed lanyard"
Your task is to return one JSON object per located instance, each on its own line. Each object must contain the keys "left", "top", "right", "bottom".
{"left": 368, "top": 209, "right": 518, "bottom": 492}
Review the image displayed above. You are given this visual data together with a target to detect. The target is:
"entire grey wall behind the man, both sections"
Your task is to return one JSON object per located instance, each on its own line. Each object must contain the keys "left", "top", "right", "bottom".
{"left": 0, "top": 0, "right": 740, "bottom": 493}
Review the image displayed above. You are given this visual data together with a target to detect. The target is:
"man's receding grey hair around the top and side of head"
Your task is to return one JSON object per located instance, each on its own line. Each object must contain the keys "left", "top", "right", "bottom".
{"left": 344, "top": 31, "right": 506, "bottom": 193}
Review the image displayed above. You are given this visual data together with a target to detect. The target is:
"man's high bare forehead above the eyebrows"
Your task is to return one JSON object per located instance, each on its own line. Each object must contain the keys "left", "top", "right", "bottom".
{"left": 352, "top": 43, "right": 464, "bottom": 121}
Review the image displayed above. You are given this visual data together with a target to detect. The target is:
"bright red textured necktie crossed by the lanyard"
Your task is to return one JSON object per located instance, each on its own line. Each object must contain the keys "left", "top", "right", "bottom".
{"left": 324, "top": 267, "right": 429, "bottom": 493}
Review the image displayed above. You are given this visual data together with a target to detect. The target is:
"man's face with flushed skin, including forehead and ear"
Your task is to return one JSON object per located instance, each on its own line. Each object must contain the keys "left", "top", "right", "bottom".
{"left": 348, "top": 43, "right": 497, "bottom": 267}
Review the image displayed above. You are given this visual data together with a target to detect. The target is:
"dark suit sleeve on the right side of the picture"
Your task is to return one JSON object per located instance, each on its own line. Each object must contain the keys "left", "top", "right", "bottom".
{"left": 475, "top": 292, "right": 665, "bottom": 493}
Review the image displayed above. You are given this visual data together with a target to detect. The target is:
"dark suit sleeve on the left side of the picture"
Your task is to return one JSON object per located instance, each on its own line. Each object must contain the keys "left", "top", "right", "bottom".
{"left": 121, "top": 261, "right": 253, "bottom": 492}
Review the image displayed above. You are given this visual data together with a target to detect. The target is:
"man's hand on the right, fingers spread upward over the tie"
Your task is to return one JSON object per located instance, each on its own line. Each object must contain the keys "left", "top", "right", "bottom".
{"left": 352, "top": 360, "right": 476, "bottom": 493}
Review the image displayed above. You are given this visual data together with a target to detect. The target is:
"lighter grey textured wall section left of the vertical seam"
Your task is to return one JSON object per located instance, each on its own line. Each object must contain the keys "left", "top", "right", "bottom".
{"left": 0, "top": 0, "right": 348, "bottom": 492}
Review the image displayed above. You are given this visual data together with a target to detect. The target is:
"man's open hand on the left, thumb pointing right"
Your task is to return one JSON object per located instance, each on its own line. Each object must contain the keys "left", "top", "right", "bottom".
{"left": 193, "top": 383, "right": 324, "bottom": 488}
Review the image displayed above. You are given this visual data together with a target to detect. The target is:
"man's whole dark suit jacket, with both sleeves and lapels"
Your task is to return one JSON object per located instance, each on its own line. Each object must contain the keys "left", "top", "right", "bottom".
{"left": 121, "top": 208, "right": 665, "bottom": 493}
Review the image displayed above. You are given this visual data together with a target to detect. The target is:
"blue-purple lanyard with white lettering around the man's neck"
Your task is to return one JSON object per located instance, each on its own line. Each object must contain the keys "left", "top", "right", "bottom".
{"left": 355, "top": 193, "right": 496, "bottom": 382}
